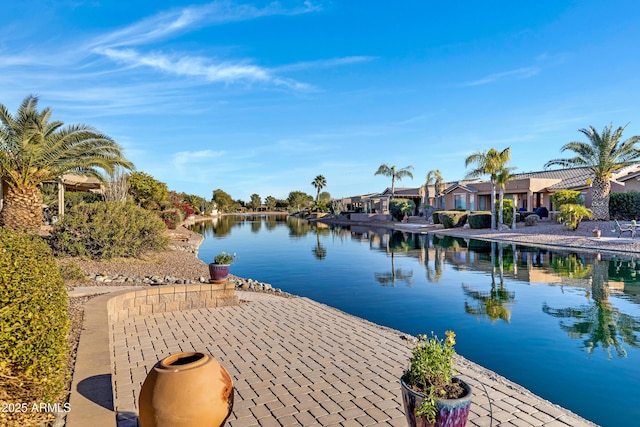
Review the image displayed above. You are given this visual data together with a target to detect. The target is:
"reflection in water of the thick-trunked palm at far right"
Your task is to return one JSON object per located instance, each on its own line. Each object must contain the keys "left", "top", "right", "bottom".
{"left": 542, "top": 259, "right": 640, "bottom": 359}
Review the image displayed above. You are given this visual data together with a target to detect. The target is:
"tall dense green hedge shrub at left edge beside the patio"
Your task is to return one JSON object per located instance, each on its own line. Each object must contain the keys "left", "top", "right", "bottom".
{"left": 0, "top": 228, "right": 69, "bottom": 401}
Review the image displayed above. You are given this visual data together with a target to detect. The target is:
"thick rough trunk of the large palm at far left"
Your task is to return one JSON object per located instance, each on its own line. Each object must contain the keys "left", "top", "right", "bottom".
{"left": 0, "top": 186, "right": 44, "bottom": 231}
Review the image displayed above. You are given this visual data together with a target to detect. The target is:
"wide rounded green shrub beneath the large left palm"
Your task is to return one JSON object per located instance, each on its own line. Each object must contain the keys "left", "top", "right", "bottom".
{"left": 51, "top": 202, "right": 168, "bottom": 259}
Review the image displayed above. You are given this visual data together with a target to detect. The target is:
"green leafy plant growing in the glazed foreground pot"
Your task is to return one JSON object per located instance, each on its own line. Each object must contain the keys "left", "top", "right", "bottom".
{"left": 402, "top": 331, "right": 466, "bottom": 423}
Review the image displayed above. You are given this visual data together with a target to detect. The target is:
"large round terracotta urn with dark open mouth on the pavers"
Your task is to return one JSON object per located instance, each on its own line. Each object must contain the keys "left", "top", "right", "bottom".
{"left": 139, "top": 352, "right": 233, "bottom": 427}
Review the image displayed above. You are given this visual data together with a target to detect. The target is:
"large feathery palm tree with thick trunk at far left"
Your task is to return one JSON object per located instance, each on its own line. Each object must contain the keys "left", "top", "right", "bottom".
{"left": 0, "top": 95, "right": 133, "bottom": 230}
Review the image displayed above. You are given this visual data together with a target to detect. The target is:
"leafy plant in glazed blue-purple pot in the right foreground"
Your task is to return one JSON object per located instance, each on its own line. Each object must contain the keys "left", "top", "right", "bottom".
{"left": 400, "top": 331, "right": 472, "bottom": 427}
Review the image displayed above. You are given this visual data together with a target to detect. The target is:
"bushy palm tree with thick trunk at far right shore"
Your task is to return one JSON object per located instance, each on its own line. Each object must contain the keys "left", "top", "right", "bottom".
{"left": 545, "top": 124, "right": 640, "bottom": 220}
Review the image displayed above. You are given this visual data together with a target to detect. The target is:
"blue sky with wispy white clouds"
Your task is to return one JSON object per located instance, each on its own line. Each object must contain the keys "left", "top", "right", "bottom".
{"left": 0, "top": 0, "right": 640, "bottom": 201}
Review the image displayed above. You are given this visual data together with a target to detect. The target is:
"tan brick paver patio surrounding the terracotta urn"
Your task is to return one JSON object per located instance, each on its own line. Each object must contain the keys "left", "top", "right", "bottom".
{"left": 111, "top": 292, "right": 593, "bottom": 427}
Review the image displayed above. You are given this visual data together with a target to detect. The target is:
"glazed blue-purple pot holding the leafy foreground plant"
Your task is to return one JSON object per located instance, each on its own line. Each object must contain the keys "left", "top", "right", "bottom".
{"left": 400, "top": 378, "right": 472, "bottom": 427}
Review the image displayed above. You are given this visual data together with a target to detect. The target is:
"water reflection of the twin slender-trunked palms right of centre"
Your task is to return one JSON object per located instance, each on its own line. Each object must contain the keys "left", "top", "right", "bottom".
{"left": 462, "top": 242, "right": 516, "bottom": 322}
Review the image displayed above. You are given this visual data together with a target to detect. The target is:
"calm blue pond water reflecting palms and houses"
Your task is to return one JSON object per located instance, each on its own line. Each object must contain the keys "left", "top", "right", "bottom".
{"left": 193, "top": 216, "right": 640, "bottom": 426}
